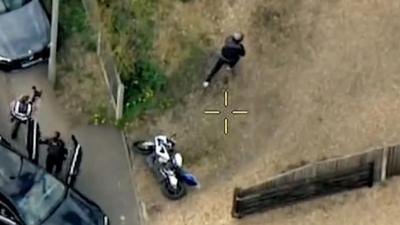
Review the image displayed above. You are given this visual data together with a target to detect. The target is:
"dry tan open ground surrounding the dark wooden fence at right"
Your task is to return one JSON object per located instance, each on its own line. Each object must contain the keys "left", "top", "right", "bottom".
{"left": 130, "top": 0, "right": 400, "bottom": 225}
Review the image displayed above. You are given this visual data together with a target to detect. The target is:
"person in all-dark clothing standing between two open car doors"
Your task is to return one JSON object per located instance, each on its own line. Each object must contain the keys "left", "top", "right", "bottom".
{"left": 40, "top": 131, "right": 68, "bottom": 176}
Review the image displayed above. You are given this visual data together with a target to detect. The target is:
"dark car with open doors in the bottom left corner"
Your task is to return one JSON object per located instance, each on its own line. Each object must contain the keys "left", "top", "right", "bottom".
{"left": 0, "top": 137, "right": 109, "bottom": 225}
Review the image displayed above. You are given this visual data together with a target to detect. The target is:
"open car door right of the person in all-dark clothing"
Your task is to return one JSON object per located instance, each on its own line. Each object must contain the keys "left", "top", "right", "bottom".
{"left": 66, "top": 135, "right": 83, "bottom": 187}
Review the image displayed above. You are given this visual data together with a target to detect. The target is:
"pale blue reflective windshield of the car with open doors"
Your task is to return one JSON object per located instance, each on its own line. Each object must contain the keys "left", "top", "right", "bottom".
{"left": 11, "top": 169, "right": 66, "bottom": 225}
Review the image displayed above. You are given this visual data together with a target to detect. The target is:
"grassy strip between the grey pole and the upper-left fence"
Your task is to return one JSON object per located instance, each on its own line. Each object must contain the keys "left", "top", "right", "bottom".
{"left": 43, "top": 0, "right": 112, "bottom": 124}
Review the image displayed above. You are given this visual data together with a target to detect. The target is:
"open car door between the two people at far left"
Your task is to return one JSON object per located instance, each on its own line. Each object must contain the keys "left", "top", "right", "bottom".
{"left": 26, "top": 120, "right": 40, "bottom": 164}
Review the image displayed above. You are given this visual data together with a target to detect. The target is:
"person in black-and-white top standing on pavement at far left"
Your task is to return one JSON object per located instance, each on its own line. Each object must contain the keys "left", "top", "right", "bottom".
{"left": 10, "top": 86, "right": 42, "bottom": 139}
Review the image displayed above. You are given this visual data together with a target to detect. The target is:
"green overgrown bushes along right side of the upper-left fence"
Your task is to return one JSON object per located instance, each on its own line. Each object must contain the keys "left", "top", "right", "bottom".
{"left": 98, "top": 0, "right": 167, "bottom": 120}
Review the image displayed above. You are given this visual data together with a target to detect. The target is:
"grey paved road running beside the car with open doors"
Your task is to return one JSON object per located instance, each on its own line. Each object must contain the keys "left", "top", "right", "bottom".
{"left": 0, "top": 65, "right": 138, "bottom": 225}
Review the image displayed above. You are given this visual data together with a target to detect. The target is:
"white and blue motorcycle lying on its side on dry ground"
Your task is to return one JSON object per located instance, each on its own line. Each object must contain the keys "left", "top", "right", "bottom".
{"left": 133, "top": 135, "right": 200, "bottom": 200}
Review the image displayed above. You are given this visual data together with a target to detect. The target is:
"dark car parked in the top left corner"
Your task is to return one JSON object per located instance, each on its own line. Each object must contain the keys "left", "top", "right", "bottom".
{"left": 0, "top": 0, "right": 50, "bottom": 71}
